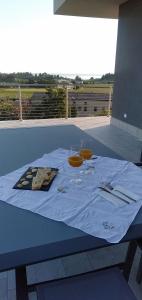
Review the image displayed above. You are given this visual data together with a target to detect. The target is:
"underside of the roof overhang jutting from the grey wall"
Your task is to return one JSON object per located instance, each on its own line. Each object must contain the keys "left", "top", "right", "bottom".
{"left": 54, "top": 0, "right": 128, "bottom": 19}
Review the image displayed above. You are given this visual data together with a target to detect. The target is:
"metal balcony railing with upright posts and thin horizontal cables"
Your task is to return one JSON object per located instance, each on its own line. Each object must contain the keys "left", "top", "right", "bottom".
{"left": 0, "top": 84, "right": 113, "bottom": 121}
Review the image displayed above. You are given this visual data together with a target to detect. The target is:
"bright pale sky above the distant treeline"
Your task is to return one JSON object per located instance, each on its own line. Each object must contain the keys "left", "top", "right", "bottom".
{"left": 0, "top": 0, "right": 117, "bottom": 77}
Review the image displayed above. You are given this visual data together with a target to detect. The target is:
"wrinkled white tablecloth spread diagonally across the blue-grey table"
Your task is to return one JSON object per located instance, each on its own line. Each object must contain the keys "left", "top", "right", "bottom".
{"left": 0, "top": 149, "right": 142, "bottom": 243}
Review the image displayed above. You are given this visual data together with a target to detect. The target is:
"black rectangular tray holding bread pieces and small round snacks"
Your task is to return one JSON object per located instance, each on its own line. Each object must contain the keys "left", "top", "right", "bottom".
{"left": 13, "top": 167, "right": 58, "bottom": 191}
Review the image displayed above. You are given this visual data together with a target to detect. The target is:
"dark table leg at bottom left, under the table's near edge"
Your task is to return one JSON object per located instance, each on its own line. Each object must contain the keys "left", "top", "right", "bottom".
{"left": 15, "top": 267, "right": 28, "bottom": 300}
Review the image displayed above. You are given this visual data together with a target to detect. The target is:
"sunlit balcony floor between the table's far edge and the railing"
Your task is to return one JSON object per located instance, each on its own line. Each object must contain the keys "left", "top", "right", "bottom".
{"left": 0, "top": 116, "right": 142, "bottom": 161}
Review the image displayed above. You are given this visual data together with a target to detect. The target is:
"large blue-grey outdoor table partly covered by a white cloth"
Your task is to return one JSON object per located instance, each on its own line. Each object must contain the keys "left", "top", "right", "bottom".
{"left": 0, "top": 125, "right": 139, "bottom": 300}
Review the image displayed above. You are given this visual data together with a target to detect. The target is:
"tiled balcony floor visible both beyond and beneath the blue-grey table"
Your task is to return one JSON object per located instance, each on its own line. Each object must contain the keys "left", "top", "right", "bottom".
{"left": 0, "top": 117, "right": 142, "bottom": 300}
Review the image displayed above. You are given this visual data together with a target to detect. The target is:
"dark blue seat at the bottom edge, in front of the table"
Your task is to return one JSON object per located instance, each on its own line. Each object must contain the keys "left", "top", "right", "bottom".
{"left": 36, "top": 268, "right": 136, "bottom": 300}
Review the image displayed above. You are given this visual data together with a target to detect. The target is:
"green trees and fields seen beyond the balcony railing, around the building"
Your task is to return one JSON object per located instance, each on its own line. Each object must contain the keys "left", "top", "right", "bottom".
{"left": 0, "top": 72, "right": 114, "bottom": 120}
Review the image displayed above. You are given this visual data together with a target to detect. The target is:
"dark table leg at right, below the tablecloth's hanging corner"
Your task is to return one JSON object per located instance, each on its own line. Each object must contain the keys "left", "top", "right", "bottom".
{"left": 123, "top": 241, "right": 137, "bottom": 281}
